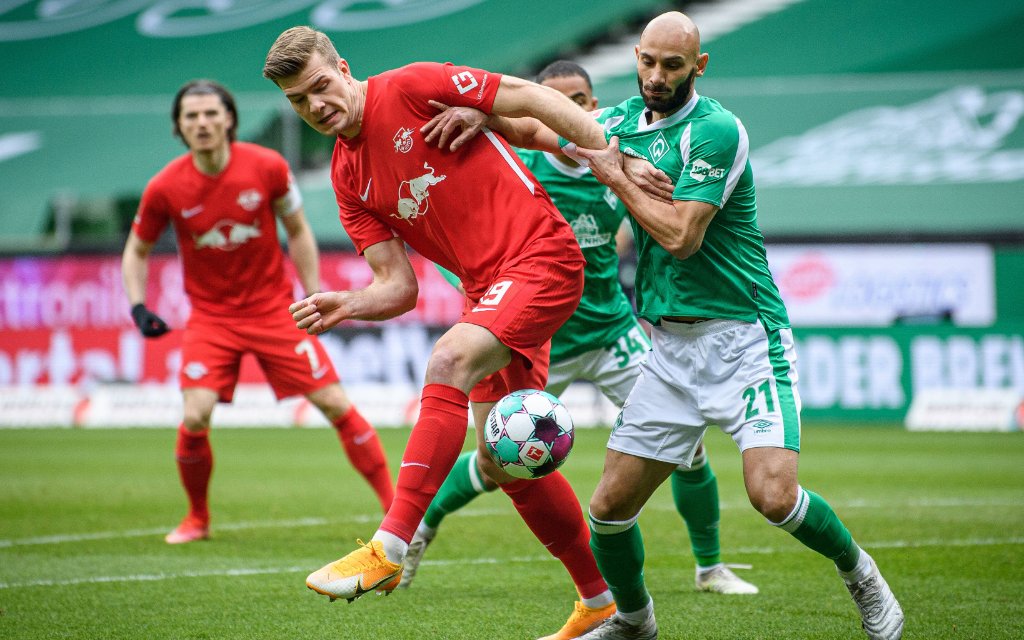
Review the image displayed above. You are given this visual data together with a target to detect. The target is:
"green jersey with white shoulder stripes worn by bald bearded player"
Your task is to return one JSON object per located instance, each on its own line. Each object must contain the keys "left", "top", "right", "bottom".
{"left": 562, "top": 93, "right": 790, "bottom": 329}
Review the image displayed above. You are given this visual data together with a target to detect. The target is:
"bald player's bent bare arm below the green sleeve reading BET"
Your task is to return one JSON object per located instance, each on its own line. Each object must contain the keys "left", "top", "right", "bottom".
{"left": 577, "top": 137, "right": 718, "bottom": 260}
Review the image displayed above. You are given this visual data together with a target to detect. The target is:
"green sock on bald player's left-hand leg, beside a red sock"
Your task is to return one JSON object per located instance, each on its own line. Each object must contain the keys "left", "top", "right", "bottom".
{"left": 590, "top": 515, "right": 650, "bottom": 613}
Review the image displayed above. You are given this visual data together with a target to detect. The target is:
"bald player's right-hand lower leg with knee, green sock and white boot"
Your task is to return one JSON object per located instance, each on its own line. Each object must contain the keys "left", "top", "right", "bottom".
{"left": 743, "top": 447, "right": 903, "bottom": 640}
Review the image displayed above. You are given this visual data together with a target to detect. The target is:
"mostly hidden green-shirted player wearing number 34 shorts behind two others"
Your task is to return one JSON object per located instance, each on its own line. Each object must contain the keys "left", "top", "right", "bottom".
{"left": 399, "top": 60, "right": 758, "bottom": 622}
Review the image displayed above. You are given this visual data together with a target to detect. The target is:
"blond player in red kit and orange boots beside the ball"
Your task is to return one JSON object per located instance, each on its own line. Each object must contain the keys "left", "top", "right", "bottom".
{"left": 263, "top": 27, "right": 671, "bottom": 637}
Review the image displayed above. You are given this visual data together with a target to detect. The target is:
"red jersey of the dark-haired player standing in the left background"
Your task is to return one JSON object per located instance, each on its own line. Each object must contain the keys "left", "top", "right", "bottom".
{"left": 132, "top": 142, "right": 301, "bottom": 317}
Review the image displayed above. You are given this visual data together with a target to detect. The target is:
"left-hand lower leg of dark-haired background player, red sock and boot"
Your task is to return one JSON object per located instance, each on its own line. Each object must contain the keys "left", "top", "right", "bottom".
{"left": 164, "top": 387, "right": 217, "bottom": 545}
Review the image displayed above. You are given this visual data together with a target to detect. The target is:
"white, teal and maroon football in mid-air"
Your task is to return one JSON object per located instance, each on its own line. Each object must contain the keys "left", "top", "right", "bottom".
{"left": 483, "top": 389, "right": 575, "bottom": 478}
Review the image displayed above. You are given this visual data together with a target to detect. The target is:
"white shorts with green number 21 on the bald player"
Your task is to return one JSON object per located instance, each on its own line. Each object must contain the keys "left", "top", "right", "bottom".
{"left": 608, "top": 319, "right": 800, "bottom": 466}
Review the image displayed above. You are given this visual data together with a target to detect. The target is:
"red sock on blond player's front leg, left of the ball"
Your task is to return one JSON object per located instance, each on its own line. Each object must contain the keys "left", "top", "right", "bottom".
{"left": 380, "top": 384, "right": 468, "bottom": 543}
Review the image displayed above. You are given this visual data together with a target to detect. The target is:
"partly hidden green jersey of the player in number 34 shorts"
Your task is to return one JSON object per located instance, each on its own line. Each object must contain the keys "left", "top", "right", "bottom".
{"left": 519, "top": 151, "right": 635, "bottom": 362}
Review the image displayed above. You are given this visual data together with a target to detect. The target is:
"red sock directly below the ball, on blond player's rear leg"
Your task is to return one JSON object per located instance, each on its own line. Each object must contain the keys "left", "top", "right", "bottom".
{"left": 502, "top": 471, "right": 608, "bottom": 598}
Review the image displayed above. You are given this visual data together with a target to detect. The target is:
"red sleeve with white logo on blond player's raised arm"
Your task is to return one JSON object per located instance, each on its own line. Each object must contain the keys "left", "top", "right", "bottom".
{"left": 397, "top": 62, "right": 502, "bottom": 114}
